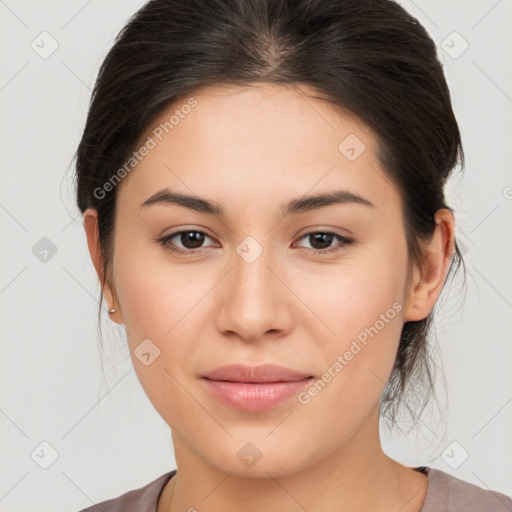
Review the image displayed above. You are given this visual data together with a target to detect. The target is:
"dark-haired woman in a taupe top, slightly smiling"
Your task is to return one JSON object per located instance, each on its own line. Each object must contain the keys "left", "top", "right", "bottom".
{"left": 77, "top": 0, "right": 512, "bottom": 512}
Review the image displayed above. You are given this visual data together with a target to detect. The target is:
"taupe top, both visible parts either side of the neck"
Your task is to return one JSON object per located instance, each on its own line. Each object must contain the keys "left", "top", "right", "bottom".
{"left": 80, "top": 466, "right": 512, "bottom": 512}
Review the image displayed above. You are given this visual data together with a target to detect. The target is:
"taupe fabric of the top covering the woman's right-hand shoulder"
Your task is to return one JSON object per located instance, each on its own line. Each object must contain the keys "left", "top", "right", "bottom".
{"left": 421, "top": 467, "right": 512, "bottom": 512}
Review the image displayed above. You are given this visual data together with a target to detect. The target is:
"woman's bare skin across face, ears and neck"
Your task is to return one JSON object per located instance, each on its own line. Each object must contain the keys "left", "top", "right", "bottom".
{"left": 84, "top": 84, "right": 455, "bottom": 512}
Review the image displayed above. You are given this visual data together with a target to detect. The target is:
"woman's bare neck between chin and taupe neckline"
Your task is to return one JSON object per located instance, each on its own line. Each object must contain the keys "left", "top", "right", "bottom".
{"left": 158, "top": 415, "right": 427, "bottom": 512}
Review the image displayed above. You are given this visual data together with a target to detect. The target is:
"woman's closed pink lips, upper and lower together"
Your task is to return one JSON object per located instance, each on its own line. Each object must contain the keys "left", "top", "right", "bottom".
{"left": 202, "top": 364, "right": 313, "bottom": 411}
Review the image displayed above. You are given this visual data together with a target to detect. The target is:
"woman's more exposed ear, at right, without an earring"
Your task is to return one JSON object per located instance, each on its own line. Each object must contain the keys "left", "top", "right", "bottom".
{"left": 404, "top": 208, "right": 455, "bottom": 322}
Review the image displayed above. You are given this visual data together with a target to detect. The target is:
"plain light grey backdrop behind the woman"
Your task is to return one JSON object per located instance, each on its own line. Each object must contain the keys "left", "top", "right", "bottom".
{"left": 0, "top": 0, "right": 512, "bottom": 512}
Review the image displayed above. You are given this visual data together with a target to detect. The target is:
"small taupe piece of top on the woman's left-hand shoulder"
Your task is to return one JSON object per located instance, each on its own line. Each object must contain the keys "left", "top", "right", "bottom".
{"left": 75, "top": 469, "right": 176, "bottom": 512}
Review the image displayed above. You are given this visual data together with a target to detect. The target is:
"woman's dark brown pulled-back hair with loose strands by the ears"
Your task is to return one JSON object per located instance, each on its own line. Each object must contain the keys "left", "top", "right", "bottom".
{"left": 75, "top": 0, "right": 466, "bottom": 432}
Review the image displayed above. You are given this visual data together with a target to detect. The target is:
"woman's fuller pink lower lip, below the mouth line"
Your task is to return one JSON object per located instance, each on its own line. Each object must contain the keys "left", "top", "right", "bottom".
{"left": 202, "top": 377, "right": 313, "bottom": 411}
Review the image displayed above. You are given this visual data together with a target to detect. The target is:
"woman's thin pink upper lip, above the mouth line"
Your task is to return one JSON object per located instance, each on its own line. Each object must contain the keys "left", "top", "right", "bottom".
{"left": 203, "top": 364, "right": 312, "bottom": 382}
